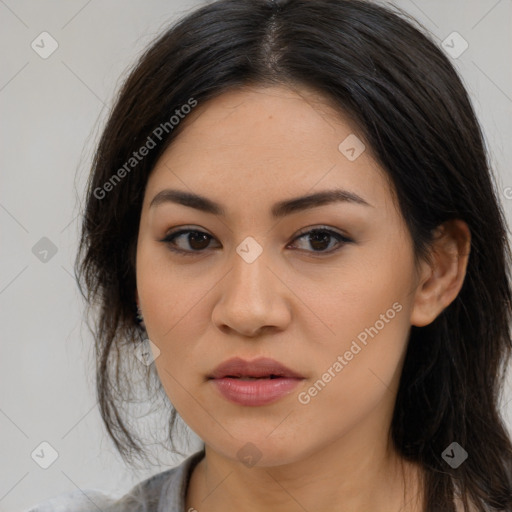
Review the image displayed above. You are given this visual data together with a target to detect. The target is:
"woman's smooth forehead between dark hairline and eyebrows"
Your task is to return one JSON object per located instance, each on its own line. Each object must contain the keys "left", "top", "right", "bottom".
{"left": 146, "top": 86, "right": 396, "bottom": 217}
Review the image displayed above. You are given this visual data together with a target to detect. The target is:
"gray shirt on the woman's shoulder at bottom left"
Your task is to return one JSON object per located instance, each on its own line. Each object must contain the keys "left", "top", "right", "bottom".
{"left": 26, "top": 449, "right": 204, "bottom": 512}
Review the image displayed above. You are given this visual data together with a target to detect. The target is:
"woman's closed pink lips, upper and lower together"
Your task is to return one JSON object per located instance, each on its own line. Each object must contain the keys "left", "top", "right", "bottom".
{"left": 208, "top": 357, "right": 304, "bottom": 406}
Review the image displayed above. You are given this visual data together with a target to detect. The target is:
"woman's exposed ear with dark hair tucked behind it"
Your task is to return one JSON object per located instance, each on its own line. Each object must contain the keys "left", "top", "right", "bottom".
{"left": 411, "top": 219, "right": 471, "bottom": 327}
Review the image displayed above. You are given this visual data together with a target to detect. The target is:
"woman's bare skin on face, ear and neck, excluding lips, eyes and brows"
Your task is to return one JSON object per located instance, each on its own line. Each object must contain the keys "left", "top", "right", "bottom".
{"left": 136, "top": 86, "right": 470, "bottom": 512}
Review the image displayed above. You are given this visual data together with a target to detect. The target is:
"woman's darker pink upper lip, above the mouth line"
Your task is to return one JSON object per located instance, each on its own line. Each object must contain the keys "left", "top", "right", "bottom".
{"left": 208, "top": 357, "right": 304, "bottom": 379}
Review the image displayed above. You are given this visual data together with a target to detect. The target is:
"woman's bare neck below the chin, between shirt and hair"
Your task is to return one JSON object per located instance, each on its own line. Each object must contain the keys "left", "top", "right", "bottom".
{"left": 186, "top": 432, "right": 423, "bottom": 512}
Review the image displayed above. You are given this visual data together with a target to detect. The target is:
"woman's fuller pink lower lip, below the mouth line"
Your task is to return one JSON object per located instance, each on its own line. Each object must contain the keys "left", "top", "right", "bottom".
{"left": 212, "top": 377, "right": 302, "bottom": 406}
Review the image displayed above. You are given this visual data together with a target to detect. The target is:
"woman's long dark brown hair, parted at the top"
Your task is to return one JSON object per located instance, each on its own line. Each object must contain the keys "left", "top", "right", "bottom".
{"left": 75, "top": 0, "right": 512, "bottom": 512}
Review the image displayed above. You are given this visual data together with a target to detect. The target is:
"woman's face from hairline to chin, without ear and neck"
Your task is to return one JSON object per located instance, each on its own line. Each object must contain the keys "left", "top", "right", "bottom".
{"left": 136, "top": 87, "right": 428, "bottom": 466}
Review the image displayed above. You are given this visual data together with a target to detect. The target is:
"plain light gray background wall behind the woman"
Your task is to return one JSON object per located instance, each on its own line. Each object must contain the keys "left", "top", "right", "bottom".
{"left": 0, "top": 0, "right": 512, "bottom": 511}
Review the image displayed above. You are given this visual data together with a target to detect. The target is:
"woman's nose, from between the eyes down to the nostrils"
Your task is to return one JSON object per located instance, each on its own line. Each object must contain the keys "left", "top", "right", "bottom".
{"left": 212, "top": 246, "right": 292, "bottom": 337}
